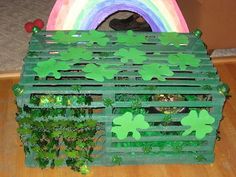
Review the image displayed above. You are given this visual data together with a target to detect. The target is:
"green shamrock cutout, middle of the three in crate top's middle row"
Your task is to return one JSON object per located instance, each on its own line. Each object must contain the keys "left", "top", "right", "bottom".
{"left": 114, "top": 48, "right": 147, "bottom": 64}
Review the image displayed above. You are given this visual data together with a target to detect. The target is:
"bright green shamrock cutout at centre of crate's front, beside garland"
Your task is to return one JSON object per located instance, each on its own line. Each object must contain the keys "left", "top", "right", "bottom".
{"left": 111, "top": 112, "right": 150, "bottom": 140}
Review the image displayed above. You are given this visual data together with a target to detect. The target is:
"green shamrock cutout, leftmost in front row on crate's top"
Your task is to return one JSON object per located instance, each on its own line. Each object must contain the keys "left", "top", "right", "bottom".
{"left": 33, "top": 59, "right": 70, "bottom": 79}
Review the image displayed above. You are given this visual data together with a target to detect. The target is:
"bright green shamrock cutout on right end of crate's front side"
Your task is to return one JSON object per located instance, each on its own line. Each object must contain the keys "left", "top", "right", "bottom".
{"left": 181, "top": 110, "right": 215, "bottom": 140}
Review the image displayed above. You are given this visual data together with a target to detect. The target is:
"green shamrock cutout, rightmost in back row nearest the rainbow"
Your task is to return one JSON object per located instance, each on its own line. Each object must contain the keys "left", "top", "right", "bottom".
{"left": 158, "top": 32, "right": 189, "bottom": 47}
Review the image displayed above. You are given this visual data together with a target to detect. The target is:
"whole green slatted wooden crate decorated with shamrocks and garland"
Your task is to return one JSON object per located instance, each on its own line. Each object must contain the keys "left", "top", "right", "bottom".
{"left": 14, "top": 31, "right": 228, "bottom": 169}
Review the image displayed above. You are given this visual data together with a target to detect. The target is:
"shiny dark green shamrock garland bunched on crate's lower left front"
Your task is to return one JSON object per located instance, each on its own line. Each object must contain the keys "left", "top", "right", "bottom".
{"left": 18, "top": 115, "right": 98, "bottom": 174}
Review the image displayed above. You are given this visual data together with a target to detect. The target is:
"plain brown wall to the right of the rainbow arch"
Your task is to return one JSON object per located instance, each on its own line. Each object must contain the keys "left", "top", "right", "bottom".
{"left": 177, "top": 0, "right": 236, "bottom": 49}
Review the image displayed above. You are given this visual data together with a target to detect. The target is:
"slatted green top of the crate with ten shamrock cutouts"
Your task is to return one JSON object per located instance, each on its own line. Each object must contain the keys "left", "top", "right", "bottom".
{"left": 19, "top": 31, "right": 220, "bottom": 97}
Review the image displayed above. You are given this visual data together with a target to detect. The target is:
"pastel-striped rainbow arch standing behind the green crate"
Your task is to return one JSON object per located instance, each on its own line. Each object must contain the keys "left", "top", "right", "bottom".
{"left": 47, "top": 0, "right": 189, "bottom": 32}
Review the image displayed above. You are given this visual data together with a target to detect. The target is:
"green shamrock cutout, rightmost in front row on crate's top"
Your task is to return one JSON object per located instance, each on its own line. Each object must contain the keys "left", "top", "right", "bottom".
{"left": 139, "top": 63, "right": 174, "bottom": 81}
